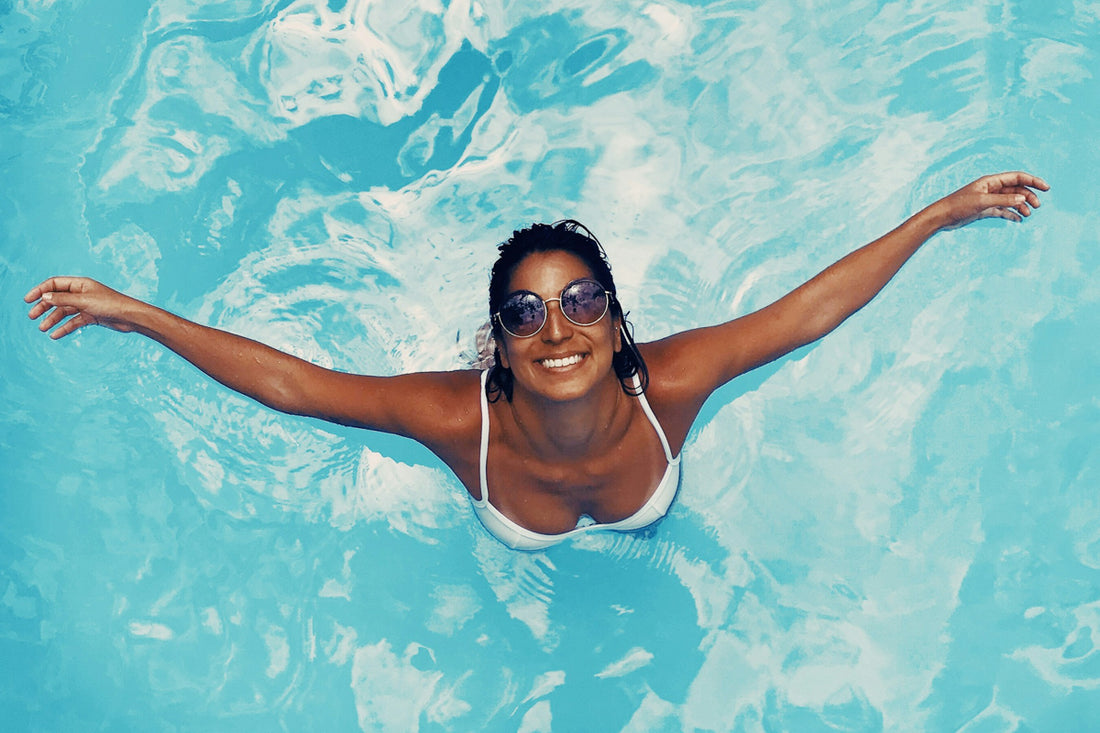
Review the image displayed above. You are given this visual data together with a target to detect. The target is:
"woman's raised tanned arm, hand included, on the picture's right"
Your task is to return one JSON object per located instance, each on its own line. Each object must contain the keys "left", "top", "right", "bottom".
{"left": 644, "top": 172, "right": 1049, "bottom": 409}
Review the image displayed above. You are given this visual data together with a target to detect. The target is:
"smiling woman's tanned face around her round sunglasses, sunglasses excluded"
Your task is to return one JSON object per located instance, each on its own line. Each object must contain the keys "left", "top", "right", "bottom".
{"left": 501, "top": 250, "right": 622, "bottom": 402}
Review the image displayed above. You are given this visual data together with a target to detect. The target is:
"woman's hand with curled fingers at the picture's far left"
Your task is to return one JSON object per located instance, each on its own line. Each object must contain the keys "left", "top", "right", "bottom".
{"left": 23, "top": 277, "right": 144, "bottom": 339}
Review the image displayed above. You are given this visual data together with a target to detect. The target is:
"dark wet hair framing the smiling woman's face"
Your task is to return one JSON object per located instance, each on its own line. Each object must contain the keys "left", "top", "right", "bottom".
{"left": 485, "top": 219, "right": 649, "bottom": 402}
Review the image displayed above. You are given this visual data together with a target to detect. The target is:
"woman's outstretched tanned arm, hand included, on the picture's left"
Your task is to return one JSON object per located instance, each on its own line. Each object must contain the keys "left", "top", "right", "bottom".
{"left": 23, "top": 277, "right": 477, "bottom": 442}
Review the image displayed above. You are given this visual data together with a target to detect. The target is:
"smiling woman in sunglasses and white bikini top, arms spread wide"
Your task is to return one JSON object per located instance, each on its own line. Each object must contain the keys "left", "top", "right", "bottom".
{"left": 24, "top": 172, "right": 1049, "bottom": 549}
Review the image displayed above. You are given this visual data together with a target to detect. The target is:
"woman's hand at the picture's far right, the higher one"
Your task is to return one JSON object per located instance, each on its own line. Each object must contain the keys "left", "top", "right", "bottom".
{"left": 928, "top": 171, "right": 1051, "bottom": 231}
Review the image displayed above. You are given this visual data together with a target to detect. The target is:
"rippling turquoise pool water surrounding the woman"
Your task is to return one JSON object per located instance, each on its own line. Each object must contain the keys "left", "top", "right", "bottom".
{"left": 0, "top": 0, "right": 1100, "bottom": 733}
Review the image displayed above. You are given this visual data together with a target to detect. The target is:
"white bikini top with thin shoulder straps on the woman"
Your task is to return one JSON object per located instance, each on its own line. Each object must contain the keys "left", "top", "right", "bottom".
{"left": 473, "top": 371, "right": 680, "bottom": 550}
